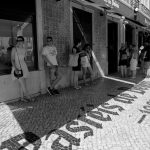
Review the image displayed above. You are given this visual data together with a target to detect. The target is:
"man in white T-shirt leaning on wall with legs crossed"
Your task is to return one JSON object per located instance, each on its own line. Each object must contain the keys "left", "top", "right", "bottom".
{"left": 42, "top": 36, "right": 61, "bottom": 95}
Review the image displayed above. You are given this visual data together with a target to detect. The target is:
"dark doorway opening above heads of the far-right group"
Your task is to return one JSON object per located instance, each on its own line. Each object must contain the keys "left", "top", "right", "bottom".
{"left": 125, "top": 24, "right": 133, "bottom": 45}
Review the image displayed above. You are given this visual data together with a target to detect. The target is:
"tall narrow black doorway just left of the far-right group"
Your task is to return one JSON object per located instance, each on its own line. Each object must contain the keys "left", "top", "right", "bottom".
{"left": 108, "top": 21, "right": 118, "bottom": 74}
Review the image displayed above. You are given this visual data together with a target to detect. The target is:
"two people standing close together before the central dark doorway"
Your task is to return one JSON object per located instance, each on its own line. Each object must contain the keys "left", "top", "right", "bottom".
{"left": 69, "top": 39, "right": 93, "bottom": 89}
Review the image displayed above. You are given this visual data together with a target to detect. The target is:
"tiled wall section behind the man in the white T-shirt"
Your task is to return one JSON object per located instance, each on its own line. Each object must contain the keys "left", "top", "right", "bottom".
{"left": 42, "top": 0, "right": 70, "bottom": 65}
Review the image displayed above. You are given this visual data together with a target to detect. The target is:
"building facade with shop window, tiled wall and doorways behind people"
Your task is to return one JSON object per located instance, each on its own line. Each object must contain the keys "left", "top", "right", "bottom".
{"left": 0, "top": 0, "right": 150, "bottom": 102}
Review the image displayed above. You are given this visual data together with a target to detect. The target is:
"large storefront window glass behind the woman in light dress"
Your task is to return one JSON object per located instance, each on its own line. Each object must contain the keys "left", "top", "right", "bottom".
{"left": 0, "top": 17, "right": 35, "bottom": 75}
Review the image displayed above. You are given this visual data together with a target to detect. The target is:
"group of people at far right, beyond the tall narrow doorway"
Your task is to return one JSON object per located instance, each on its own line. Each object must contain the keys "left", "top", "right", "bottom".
{"left": 119, "top": 42, "right": 150, "bottom": 78}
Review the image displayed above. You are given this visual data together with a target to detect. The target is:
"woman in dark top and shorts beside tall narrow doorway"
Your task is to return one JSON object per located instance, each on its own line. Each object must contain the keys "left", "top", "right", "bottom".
{"left": 119, "top": 43, "right": 128, "bottom": 77}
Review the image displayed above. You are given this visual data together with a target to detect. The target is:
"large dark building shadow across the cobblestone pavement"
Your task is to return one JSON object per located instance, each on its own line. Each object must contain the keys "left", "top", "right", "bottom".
{"left": 2, "top": 74, "right": 145, "bottom": 150}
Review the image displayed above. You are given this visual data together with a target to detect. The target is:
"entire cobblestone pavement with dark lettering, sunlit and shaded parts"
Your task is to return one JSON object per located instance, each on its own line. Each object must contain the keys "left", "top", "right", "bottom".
{"left": 0, "top": 75, "right": 150, "bottom": 150}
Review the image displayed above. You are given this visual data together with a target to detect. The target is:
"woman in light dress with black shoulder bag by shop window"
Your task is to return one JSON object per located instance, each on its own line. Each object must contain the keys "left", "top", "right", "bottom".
{"left": 11, "top": 36, "right": 33, "bottom": 102}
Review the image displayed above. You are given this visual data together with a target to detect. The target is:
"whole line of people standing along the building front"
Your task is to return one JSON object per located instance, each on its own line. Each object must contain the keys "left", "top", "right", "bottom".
{"left": 11, "top": 36, "right": 150, "bottom": 102}
